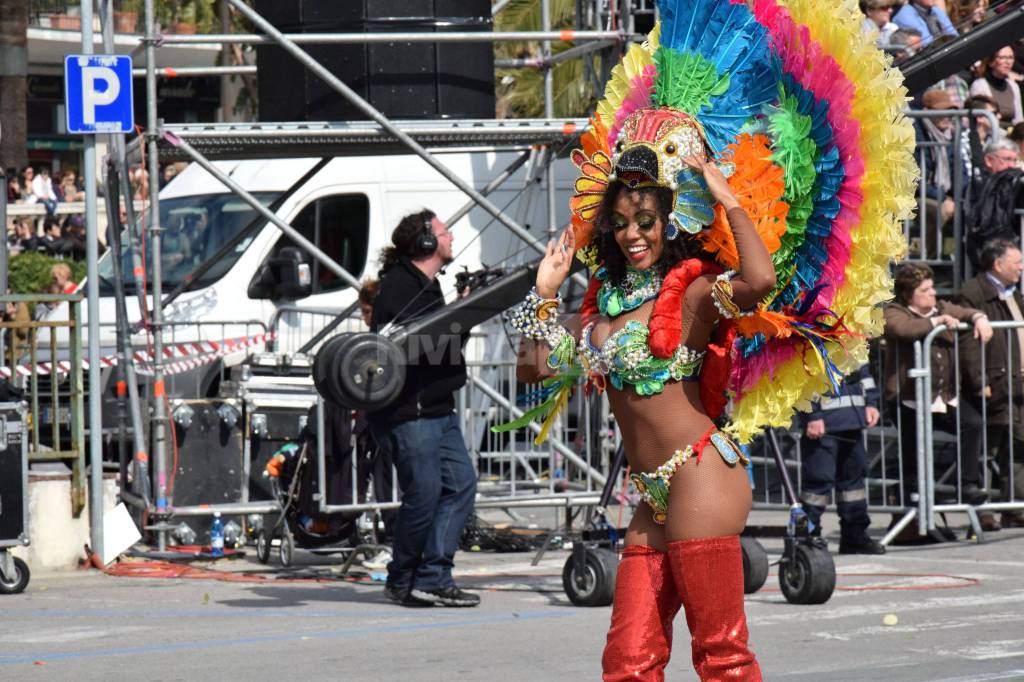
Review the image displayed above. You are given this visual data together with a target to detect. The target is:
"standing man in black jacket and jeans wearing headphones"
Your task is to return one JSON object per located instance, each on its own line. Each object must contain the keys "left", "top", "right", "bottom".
{"left": 368, "top": 206, "right": 480, "bottom": 606}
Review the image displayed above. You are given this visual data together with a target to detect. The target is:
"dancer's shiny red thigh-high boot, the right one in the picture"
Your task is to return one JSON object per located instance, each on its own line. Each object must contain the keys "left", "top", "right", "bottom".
{"left": 669, "top": 536, "right": 761, "bottom": 682}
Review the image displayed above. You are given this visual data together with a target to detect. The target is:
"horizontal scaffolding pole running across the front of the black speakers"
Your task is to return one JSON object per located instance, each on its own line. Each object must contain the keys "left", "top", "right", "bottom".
{"left": 160, "top": 29, "right": 626, "bottom": 45}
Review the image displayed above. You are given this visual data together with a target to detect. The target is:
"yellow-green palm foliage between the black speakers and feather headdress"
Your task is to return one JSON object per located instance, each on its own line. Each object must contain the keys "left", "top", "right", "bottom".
{"left": 495, "top": 0, "right": 603, "bottom": 118}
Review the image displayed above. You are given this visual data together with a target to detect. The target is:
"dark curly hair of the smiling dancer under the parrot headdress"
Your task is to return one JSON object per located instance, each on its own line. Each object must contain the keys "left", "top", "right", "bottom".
{"left": 594, "top": 180, "right": 710, "bottom": 285}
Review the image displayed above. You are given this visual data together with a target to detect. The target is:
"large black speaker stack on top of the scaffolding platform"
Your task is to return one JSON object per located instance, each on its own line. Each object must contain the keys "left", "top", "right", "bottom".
{"left": 256, "top": 0, "right": 495, "bottom": 121}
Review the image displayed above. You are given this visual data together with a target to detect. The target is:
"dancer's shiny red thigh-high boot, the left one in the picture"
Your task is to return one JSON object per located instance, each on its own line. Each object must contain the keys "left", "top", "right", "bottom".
{"left": 601, "top": 545, "right": 680, "bottom": 682}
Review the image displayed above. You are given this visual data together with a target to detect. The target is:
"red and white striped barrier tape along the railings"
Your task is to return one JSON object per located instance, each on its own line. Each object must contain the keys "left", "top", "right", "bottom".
{"left": 0, "top": 332, "right": 274, "bottom": 379}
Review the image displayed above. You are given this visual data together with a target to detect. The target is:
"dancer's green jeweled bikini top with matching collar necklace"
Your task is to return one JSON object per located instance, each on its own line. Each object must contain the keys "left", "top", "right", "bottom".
{"left": 577, "top": 268, "right": 706, "bottom": 395}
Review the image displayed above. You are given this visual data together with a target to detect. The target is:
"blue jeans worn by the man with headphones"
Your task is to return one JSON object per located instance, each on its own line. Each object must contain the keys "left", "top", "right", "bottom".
{"left": 374, "top": 414, "right": 476, "bottom": 590}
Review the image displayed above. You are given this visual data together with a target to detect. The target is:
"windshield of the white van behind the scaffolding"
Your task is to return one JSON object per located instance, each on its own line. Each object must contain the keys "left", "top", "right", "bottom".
{"left": 99, "top": 191, "right": 281, "bottom": 296}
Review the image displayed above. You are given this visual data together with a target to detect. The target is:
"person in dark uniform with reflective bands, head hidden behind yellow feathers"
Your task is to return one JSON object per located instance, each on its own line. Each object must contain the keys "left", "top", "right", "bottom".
{"left": 800, "top": 365, "right": 886, "bottom": 554}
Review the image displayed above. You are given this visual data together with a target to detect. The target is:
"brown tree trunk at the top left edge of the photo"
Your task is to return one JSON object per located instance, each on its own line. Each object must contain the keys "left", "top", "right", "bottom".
{"left": 0, "top": 0, "right": 29, "bottom": 168}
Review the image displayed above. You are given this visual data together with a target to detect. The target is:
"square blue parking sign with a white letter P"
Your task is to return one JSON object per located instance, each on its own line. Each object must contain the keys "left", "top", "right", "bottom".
{"left": 65, "top": 54, "right": 134, "bottom": 133}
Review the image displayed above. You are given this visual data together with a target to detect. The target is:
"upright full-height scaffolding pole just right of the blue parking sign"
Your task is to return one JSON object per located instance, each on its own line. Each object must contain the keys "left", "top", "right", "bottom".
{"left": 145, "top": 0, "right": 173, "bottom": 551}
